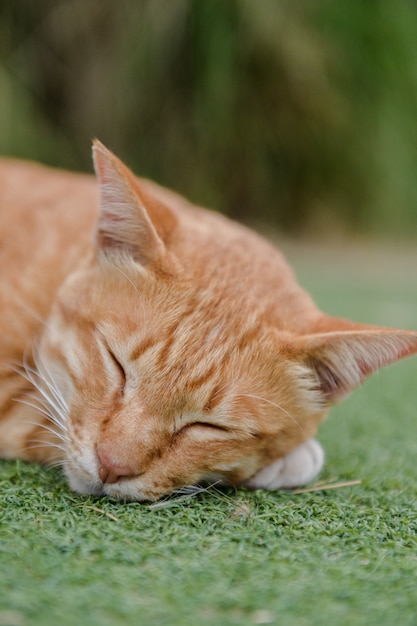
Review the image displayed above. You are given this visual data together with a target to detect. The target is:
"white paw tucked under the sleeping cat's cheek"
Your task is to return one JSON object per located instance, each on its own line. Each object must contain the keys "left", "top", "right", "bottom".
{"left": 244, "top": 439, "right": 324, "bottom": 489}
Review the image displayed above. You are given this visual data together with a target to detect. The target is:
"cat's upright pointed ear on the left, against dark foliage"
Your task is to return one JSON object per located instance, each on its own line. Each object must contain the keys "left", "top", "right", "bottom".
{"left": 93, "top": 140, "right": 165, "bottom": 266}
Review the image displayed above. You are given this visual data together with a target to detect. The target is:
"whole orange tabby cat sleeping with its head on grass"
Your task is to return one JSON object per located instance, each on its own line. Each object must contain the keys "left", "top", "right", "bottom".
{"left": 0, "top": 141, "right": 417, "bottom": 500}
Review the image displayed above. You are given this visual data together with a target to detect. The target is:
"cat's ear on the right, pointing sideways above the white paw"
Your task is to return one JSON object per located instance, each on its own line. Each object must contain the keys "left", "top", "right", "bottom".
{"left": 296, "top": 329, "right": 417, "bottom": 404}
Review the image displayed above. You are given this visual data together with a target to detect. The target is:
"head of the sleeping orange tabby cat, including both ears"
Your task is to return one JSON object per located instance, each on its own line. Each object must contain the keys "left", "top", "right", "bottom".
{"left": 37, "top": 142, "right": 417, "bottom": 500}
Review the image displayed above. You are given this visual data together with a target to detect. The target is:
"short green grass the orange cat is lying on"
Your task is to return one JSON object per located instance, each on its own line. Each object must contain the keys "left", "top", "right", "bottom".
{"left": 0, "top": 241, "right": 417, "bottom": 626}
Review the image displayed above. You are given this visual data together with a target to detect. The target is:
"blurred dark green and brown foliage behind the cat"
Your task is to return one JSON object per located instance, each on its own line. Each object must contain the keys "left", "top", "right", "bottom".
{"left": 0, "top": 0, "right": 417, "bottom": 239}
